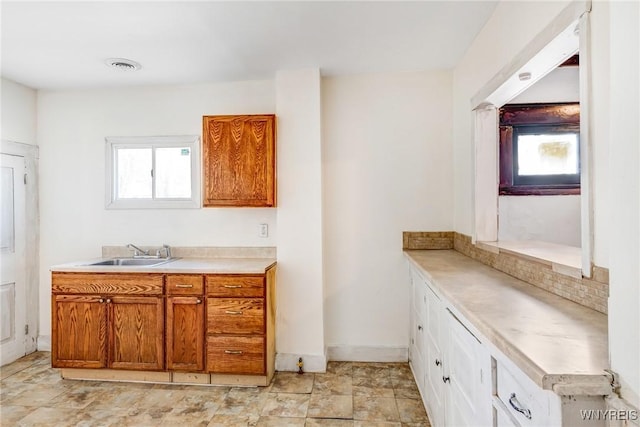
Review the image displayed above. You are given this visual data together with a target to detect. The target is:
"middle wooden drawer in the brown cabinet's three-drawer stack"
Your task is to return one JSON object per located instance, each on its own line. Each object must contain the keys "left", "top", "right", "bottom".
{"left": 207, "top": 298, "right": 264, "bottom": 334}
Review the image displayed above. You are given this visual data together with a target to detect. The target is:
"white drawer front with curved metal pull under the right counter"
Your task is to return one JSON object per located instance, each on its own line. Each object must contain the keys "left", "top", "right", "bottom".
{"left": 496, "top": 361, "right": 550, "bottom": 427}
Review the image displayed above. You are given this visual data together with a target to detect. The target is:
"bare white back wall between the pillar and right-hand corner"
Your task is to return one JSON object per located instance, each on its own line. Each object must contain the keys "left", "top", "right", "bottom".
{"left": 322, "top": 71, "right": 452, "bottom": 360}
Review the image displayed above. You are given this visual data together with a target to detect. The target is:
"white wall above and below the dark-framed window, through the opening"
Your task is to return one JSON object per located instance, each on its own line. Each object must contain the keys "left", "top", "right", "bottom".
{"left": 498, "top": 67, "right": 581, "bottom": 247}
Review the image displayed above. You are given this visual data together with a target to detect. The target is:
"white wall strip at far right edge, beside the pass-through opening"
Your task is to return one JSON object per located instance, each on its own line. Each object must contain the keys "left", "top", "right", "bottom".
{"left": 609, "top": 2, "right": 640, "bottom": 410}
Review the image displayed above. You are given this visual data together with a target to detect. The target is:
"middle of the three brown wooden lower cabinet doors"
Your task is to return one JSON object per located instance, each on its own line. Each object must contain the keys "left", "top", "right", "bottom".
{"left": 108, "top": 296, "right": 164, "bottom": 370}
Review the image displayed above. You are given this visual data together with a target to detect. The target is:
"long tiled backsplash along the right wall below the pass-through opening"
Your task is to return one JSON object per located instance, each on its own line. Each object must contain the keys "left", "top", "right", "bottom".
{"left": 453, "top": 233, "right": 609, "bottom": 314}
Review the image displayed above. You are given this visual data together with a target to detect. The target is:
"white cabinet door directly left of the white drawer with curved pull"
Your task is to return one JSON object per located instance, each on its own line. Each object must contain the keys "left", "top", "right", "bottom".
{"left": 443, "top": 310, "right": 492, "bottom": 427}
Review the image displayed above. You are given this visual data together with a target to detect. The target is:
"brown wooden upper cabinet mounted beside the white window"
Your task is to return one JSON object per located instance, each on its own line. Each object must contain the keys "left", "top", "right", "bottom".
{"left": 202, "top": 114, "right": 276, "bottom": 207}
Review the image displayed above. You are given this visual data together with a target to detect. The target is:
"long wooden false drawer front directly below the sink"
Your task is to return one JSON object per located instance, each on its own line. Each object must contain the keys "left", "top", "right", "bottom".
{"left": 51, "top": 273, "right": 163, "bottom": 295}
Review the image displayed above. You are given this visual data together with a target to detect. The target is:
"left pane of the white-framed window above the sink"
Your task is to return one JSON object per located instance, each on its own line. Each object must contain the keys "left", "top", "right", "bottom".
{"left": 116, "top": 148, "right": 152, "bottom": 199}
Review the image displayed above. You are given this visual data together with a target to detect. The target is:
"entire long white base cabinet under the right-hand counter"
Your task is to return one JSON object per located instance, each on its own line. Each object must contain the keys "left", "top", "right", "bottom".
{"left": 409, "top": 264, "right": 608, "bottom": 427}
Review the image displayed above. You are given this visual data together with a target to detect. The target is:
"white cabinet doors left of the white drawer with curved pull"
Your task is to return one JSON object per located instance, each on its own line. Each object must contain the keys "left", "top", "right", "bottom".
{"left": 410, "top": 268, "right": 492, "bottom": 427}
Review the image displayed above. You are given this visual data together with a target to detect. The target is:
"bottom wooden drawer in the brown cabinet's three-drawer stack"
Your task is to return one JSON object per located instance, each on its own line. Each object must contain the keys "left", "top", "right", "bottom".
{"left": 207, "top": 336, "right": 265, "bottom": 375}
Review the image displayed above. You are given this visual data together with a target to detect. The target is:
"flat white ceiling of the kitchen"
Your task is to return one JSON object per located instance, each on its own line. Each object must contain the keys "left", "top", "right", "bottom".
{"left": 0, "top": 0, "right": 497, "bottom": 89}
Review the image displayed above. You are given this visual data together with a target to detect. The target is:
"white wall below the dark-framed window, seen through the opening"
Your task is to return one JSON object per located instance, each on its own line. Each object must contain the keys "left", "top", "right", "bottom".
{"left": 498, "top": 196, "right": 580, "bottom": 247}
